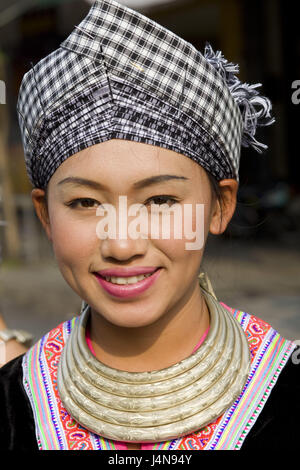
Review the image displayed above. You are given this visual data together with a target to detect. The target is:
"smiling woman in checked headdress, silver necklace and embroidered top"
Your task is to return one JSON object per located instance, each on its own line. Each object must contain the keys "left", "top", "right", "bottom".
{"left": 0, "top": 0, "right": 299, "bottom": 450}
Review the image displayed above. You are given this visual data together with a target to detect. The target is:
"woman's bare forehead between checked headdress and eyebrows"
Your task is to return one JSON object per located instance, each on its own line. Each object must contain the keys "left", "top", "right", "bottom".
{"left": 49, "top": 139, "right": 205, "bottom": 191}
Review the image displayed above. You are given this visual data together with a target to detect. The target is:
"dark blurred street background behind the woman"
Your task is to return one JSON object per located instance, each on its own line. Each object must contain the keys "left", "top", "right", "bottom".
{"left": 0, "top": 0, "right": 300, "bottom": 339}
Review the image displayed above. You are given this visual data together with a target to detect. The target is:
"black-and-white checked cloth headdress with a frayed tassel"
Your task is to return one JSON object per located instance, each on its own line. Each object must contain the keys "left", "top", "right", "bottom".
{"left": 18, "top": 0, "right": 273, "bottom": 188}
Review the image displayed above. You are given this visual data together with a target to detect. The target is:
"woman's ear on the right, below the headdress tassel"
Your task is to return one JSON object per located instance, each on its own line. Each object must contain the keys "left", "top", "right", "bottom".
{"left": 209, "top": 179, "right": 239, "bottom": 235}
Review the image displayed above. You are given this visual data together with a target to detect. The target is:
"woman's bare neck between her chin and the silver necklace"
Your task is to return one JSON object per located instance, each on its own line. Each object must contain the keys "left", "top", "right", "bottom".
{"left": 90, "top": 282, "right": 209, "bottom": 372}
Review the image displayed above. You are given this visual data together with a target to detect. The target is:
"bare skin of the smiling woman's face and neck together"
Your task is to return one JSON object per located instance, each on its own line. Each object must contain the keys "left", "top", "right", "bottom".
{"left": 32, "top": 140, "right": 217, "bottom": 346}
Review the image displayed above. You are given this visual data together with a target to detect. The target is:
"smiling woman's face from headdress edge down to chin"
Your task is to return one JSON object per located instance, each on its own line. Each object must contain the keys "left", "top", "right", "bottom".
{"left": 32, "top": 140, "right": 237, "bottom": 327}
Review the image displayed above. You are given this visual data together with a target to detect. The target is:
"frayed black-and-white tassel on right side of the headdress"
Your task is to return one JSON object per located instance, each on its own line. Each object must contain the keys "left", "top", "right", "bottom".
{"left": 204, "top": 43, "right": 275, "bottom": 153}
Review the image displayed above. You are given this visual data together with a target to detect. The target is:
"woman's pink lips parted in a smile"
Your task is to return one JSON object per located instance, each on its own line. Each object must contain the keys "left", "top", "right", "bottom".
{"left": 94, "top": 268, "right": 162, "bottom": 298}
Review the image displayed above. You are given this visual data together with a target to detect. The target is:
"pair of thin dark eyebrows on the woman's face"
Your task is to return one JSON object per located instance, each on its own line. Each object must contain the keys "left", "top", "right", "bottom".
{"left": 57, "top": 175, "right": 189, "bottom": 190}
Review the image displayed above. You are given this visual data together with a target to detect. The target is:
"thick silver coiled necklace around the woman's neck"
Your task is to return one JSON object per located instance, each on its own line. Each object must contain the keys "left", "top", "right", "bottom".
{"left": 58, "top": 276, "right": 250, "bottom": 442}
